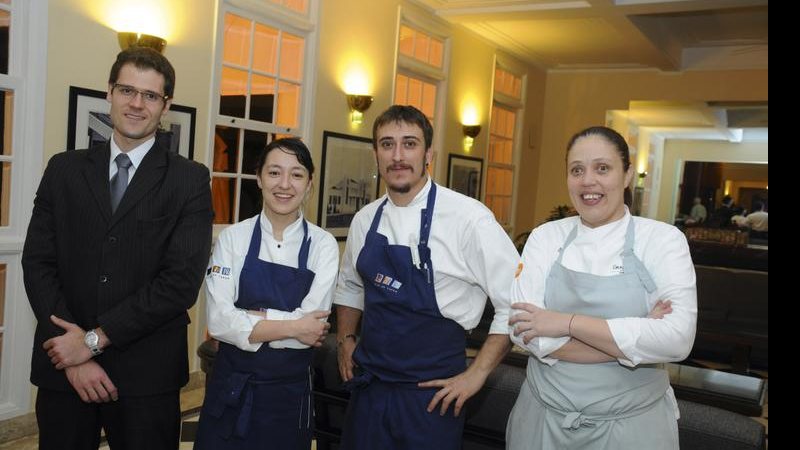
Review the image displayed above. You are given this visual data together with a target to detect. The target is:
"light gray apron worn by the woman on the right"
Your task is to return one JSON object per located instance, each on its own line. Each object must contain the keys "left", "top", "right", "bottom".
{"left": 506, "top": 217, "right": 678, "bottom": 450}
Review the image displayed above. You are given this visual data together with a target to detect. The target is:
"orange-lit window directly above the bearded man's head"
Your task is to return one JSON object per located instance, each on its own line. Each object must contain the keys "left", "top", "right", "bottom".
{"left": 394, "top": 22, "right": 447, "bottom": 175}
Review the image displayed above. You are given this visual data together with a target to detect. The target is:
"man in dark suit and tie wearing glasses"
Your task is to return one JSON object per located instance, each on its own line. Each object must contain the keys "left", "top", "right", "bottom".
{"left": 22, "top": 47, "right": 213, "bottom": 450}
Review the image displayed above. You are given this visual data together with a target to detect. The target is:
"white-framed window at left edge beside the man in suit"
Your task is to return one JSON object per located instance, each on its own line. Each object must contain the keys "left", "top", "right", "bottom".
{"left": 0, "top": 0, "right": 47, "bottom": 420}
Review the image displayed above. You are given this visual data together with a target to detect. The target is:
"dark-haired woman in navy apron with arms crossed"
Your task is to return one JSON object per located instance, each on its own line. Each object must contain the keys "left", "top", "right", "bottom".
{"left": 195, "top": 138, "right": 339, "bottom": 450}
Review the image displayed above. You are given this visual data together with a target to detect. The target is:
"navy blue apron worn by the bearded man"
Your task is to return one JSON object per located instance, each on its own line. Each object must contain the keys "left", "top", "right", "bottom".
{"left": 342, "top": 183, "right": 466, "bottom": 450}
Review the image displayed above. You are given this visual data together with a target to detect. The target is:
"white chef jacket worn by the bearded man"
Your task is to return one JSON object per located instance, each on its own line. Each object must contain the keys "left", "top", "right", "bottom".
{"left": 333, "top": 179, "right": 519, "bottom": 334}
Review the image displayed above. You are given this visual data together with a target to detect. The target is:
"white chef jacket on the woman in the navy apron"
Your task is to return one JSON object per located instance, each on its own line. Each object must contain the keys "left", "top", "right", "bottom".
{"left": 206, "top": 211, "right": 339, "bottom": 352}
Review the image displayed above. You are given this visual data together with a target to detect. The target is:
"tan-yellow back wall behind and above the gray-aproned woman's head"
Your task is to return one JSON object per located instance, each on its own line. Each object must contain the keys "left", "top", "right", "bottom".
{"left": 532, "top": 70, "right": 768, "bottom": 231}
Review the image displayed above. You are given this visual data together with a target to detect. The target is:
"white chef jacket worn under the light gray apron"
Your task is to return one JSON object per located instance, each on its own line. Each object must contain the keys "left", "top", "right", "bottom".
{"left": 511, "top": 207, "right": 697, "bottom": 367}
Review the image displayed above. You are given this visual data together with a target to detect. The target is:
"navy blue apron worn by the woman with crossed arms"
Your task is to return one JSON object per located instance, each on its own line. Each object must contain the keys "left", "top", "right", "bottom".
{"left": 194, "top": 215, "right": 314, "bottom": 450}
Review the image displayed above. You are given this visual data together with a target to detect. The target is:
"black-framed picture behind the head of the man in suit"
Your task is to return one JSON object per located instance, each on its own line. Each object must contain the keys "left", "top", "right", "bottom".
{"left": 67, "top": 86, "right": 197, "bottom": 159}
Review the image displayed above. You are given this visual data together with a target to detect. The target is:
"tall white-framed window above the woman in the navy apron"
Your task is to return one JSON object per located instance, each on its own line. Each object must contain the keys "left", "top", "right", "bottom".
{"left": 210, "top": 0, "right": 316, "bottom": 224}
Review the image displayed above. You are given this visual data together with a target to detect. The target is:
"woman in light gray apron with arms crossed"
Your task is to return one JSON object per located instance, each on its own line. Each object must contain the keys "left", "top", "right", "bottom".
{"left": 506, "top": 127, "right": 697, "bottom": 450}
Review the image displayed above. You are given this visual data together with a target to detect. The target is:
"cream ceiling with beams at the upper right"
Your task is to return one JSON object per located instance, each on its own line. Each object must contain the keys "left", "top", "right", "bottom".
{"left": 415, "top": 0, "right": 769, "bottom": 71}
